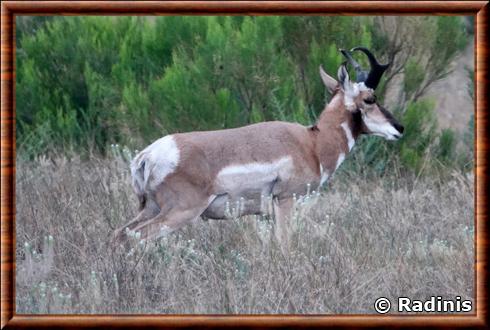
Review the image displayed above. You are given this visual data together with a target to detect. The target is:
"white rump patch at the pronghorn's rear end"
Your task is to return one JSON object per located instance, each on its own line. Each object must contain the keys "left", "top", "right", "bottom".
{"left": 131, "top": 135, "right": 180, "bottom": 189}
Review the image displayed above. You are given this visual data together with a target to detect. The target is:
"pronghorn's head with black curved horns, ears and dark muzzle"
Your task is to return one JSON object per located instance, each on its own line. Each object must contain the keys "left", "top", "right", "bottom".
{"left": 320, "top": 47, "right": 403, "bottom": 140}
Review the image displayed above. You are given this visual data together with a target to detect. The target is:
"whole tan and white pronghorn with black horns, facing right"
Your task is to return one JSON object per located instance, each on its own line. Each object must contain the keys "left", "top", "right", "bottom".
{"left": 116, "top": 47, "right": 403, "bottom": 250}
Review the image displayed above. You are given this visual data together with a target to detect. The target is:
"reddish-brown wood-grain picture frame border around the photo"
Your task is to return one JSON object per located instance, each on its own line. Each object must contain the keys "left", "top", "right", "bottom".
{"left": 0, "top": 1, "right": 490, "bottom": 329}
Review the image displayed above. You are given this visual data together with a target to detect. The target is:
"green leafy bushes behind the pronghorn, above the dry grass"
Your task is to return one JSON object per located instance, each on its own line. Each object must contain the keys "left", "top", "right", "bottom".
{"left": 16, "top": 16, "right": 470, "bottom": 173}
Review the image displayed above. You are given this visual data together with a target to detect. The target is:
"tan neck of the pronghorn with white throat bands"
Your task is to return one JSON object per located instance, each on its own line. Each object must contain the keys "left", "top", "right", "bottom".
{"left": 315, "top": 93, "right": 362, "bottom": 175}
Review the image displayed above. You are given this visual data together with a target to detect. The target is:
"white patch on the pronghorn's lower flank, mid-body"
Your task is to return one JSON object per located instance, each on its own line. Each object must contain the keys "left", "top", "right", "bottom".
{"left": 216, "top": 156, "right": 293, "bottom": 195}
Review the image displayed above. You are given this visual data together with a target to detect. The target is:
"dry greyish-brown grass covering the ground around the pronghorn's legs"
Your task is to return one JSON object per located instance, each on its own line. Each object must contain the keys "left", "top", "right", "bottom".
{"left": 16, "top": 153, "right": 474, "bottom": 314}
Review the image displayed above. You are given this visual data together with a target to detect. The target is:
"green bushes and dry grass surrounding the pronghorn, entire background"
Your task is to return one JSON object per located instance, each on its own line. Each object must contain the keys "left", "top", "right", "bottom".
{"left": 16, "top": 16, "right": 474, "bottom": 313}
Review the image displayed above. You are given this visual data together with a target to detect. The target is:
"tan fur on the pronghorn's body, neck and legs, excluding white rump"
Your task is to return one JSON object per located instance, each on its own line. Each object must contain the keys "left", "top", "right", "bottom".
{"left": 116, "top": 66, "right": 402, "bottom": 253}
